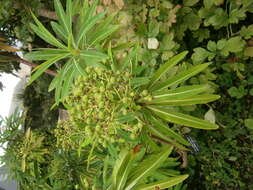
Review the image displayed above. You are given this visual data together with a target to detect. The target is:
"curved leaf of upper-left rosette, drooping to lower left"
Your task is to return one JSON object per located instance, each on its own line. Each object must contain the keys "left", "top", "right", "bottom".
{"left": 28, "top": 54, "right": 70, "bottom": 85}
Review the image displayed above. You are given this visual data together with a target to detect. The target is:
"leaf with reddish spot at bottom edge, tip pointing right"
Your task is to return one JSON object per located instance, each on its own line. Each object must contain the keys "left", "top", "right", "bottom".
{"left": 133, "top": 175, "right": 189, "bottom": 190}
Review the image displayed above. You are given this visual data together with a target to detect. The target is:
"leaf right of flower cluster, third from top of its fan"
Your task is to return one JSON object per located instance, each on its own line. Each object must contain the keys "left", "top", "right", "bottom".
{"left": 152, "top": 85, "right": 209, "bottom": 99}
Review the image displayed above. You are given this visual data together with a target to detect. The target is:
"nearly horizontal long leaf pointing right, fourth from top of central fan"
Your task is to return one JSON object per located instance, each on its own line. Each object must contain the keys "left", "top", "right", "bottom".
{"left": 148, "top": 94, "right": 220, "bottom": 106}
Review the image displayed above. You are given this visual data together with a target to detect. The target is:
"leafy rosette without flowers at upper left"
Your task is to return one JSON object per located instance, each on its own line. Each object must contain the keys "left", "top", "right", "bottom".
{"left": 25, "top": 0, "right": 118, "bottom": 104}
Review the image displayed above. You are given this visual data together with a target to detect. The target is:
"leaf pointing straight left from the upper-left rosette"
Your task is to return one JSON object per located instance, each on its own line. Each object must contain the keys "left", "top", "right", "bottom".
{"left": 24, "top": 48, "right": 68, "bottom": 61}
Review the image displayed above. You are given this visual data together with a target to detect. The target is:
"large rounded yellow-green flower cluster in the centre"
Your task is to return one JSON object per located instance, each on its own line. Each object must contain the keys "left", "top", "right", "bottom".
{"left": 58, "top": 67, "right": 152, "bottom": 147}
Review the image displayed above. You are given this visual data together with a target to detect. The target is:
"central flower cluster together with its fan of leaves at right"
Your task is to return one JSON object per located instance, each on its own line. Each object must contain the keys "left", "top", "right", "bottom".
{"left": 56, "top": 49, "right": 219, "bottom": 149}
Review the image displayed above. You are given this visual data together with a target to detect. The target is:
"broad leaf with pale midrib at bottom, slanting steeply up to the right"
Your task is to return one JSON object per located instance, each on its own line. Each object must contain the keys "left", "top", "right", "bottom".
{"left": 124, "top": 146, "right": 173, "bottom": 190}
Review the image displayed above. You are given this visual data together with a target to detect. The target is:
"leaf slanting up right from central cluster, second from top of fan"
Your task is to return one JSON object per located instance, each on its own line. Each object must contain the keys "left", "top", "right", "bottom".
{"left": 151, "top": 63, "right": 210, "bottom": 91}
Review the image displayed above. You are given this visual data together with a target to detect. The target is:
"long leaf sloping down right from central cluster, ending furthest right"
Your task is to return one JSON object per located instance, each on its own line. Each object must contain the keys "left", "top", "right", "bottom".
{"left": 147, "top": 106, "right": 218, "bottom": 130}
